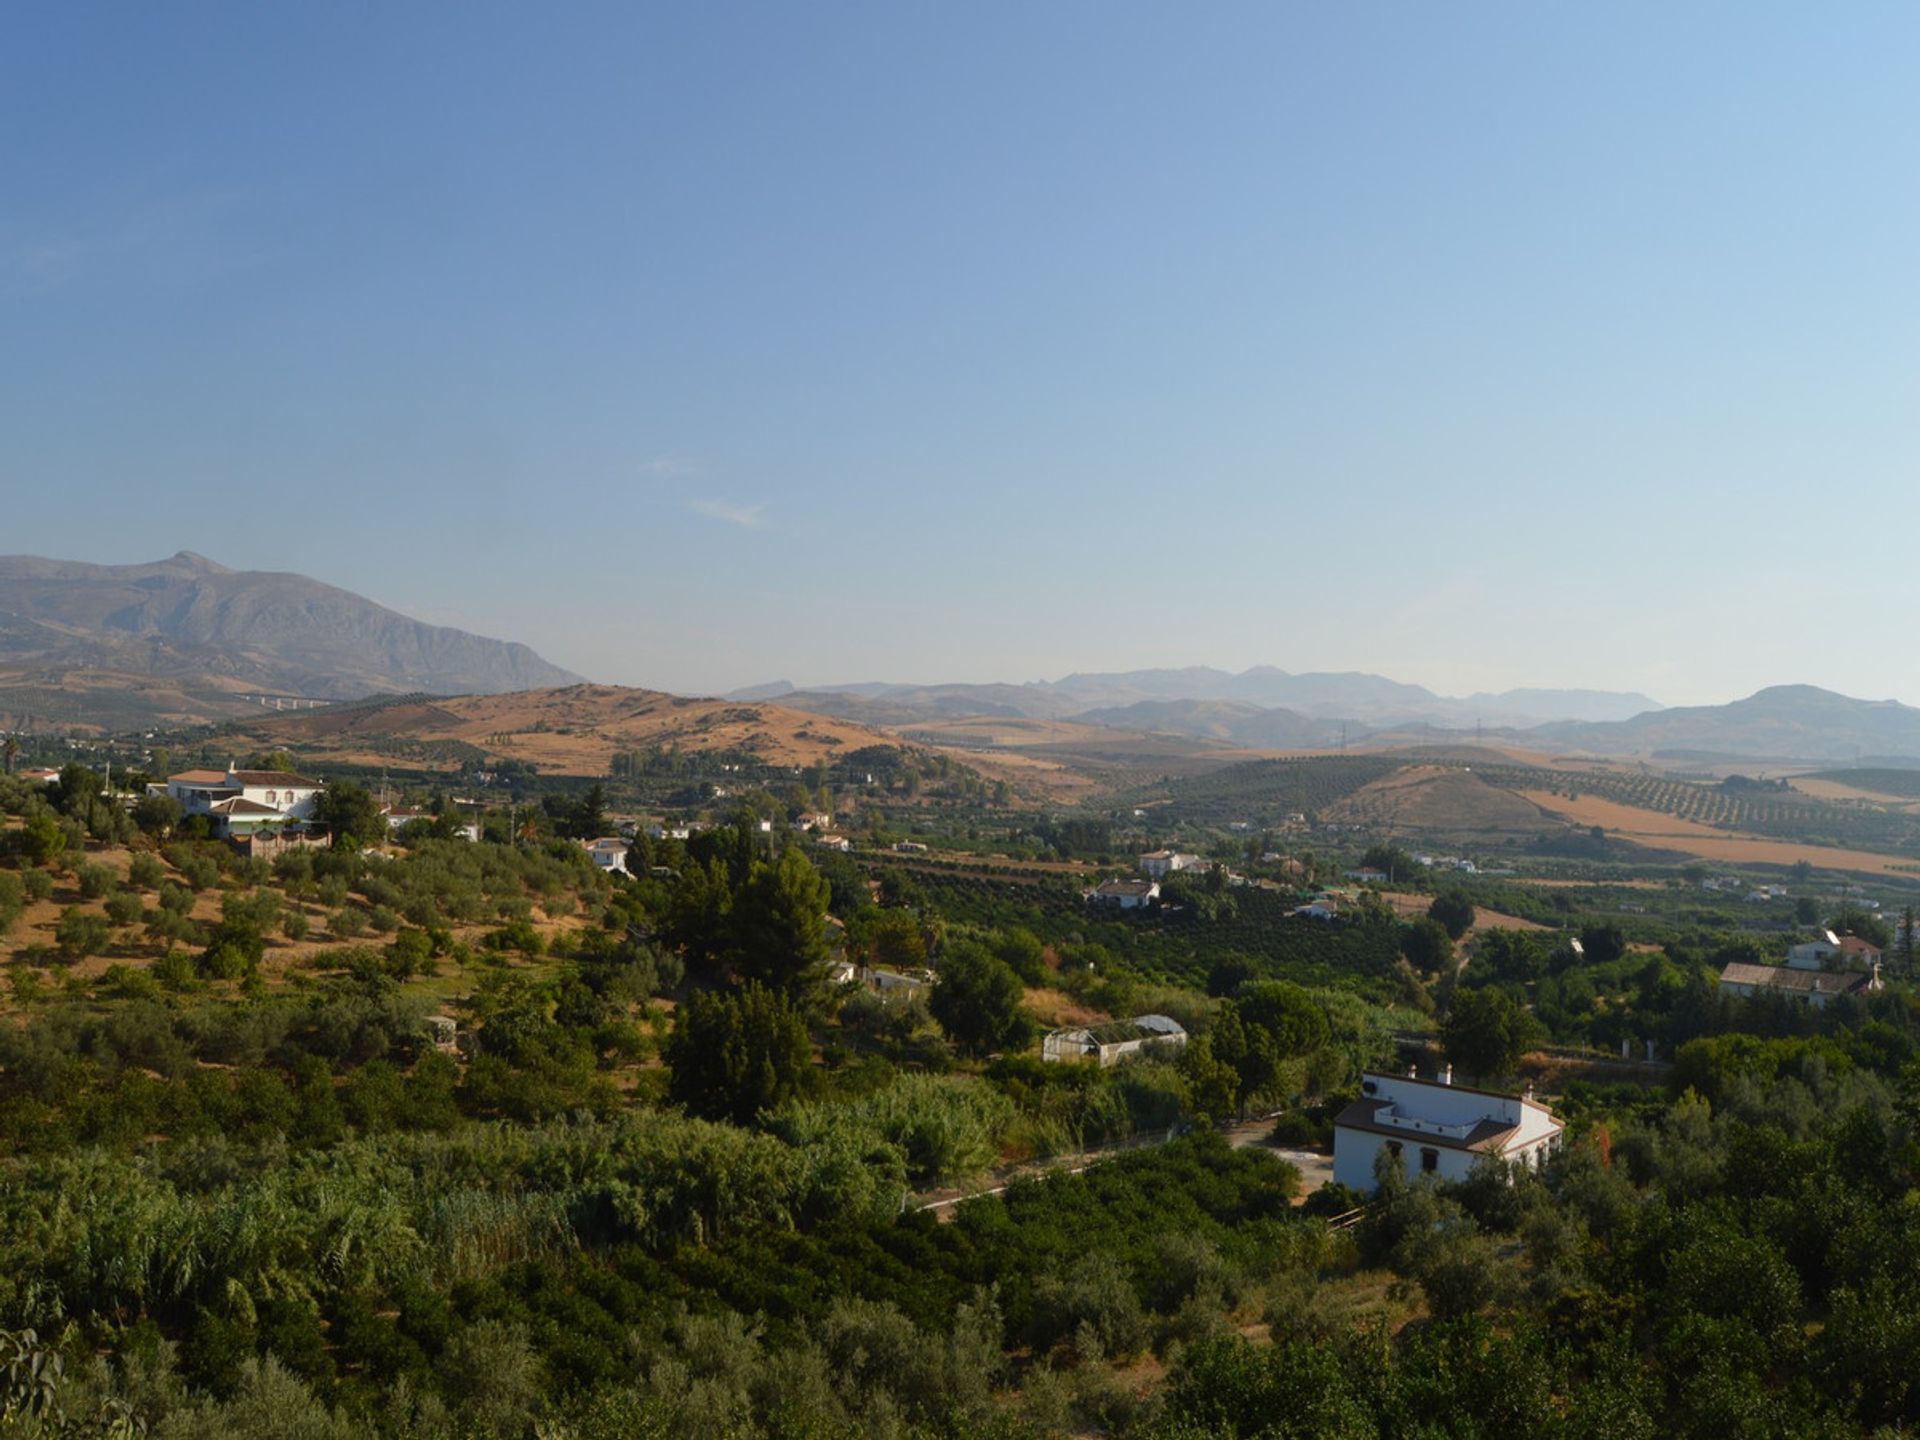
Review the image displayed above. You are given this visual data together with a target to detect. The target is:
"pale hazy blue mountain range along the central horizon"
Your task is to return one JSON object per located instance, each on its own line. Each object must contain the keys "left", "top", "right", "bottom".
{"left": 728, "top": 666, "right": 1661, "bottom": 745}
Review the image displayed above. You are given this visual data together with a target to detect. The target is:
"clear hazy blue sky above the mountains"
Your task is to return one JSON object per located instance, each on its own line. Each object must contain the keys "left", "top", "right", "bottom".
{"left": 0, "top": 0, "right": 1920, "bottom": 703}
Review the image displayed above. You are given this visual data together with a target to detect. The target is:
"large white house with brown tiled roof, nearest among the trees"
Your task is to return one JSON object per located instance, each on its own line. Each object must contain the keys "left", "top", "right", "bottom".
{"left": 1332, "top": 1068, "right": 1567, "bottom": 1194}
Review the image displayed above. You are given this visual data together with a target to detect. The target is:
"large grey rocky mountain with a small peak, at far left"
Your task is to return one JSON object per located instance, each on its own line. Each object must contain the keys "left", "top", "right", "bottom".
{"left": 0, "top": 551, "right": 580, "bottom": 733}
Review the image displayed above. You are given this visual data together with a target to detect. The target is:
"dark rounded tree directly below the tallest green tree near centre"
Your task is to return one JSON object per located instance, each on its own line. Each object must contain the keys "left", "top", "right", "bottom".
{"left": 666, "top": 981, "right": 812, "bottom": 1125}
